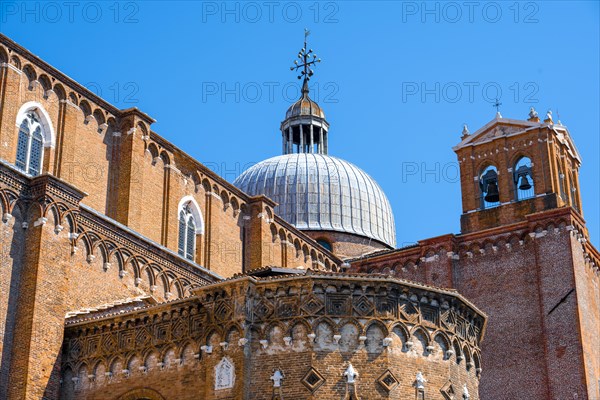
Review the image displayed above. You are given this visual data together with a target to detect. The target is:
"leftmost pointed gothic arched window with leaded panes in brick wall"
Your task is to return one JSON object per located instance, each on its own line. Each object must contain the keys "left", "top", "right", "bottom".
{"left": 15, "top": 111, "right": 44, "bottom": 175}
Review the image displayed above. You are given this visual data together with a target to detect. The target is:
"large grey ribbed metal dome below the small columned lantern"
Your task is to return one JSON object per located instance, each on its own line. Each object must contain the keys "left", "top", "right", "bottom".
{"left": 233, "top": 153, "right": 396, "bottom": 247}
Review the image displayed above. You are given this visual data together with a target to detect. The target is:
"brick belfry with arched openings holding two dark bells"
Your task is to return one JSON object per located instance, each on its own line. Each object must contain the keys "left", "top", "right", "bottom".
{"left": 454, "top": 107, "right": 583, "bottom": 233}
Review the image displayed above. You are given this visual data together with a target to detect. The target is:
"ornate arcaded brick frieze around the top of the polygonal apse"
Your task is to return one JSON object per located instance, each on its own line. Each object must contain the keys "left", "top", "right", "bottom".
{"left": 62, "top": 271, "right": 485, "bottom": 394}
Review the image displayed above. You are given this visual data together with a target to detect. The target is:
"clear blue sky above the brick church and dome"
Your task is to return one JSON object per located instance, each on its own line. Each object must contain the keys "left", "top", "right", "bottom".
{"left": 0, "top": 1, "right": 600, "bottom": 246}
